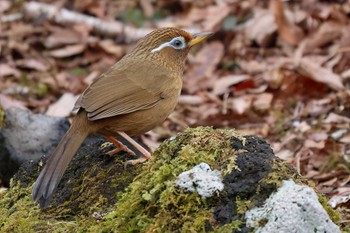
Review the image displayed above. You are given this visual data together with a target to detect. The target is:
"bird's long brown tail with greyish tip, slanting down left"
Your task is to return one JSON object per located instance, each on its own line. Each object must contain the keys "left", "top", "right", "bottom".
{"left": 32, "top": 112, "right": 90, "bottom": 208}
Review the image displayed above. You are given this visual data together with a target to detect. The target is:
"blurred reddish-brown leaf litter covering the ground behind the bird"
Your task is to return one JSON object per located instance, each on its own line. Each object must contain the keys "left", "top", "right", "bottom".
{"left": 0, "top": 0, "right": 350, "bottom": 223}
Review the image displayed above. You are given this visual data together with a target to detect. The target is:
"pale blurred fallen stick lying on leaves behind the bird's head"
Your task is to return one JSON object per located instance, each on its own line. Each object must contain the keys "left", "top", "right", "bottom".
{"left": 23, "top": 2, "right": 151, "bottom": 42}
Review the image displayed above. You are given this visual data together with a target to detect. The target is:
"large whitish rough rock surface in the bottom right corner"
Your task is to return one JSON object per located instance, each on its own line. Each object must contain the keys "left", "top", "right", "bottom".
{"left": 246, "top": 180, "right": 340, "bottom": 233}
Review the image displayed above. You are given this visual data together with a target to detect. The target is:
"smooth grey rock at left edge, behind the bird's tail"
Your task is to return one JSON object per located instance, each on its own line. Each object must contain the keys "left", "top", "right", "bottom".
{"left": 0, "top": 108, "right": 69, "bottom": 163}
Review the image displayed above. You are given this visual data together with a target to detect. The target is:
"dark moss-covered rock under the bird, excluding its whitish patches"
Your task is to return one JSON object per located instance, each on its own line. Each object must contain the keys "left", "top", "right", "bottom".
{"left": 0, "top": 127, "right": 336, "bottom": 232}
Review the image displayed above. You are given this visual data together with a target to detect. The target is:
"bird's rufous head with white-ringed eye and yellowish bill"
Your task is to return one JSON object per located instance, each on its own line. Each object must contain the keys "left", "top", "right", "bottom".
{"left": 129, "top": 28, "right": 213, "bottom": 71}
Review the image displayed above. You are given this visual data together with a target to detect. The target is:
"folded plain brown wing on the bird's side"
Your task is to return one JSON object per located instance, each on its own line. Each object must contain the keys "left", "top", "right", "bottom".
{"left": 74, "top": 60, "right": 163, "bottom": 120}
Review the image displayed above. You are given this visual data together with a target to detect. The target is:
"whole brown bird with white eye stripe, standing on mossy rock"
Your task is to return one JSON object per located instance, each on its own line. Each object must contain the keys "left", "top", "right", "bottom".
{"left": 32, "top": 28, "right": 212, "bottom": 208}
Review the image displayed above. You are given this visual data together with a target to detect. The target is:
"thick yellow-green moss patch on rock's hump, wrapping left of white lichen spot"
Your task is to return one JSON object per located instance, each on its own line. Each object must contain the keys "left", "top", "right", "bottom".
{"left": 106, "top": 127, "right": 244, "bottom": 232}
